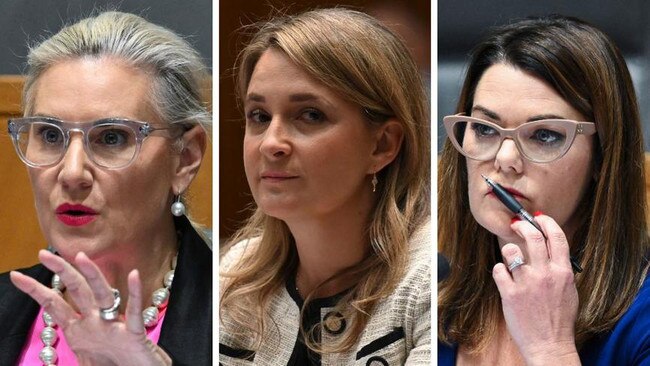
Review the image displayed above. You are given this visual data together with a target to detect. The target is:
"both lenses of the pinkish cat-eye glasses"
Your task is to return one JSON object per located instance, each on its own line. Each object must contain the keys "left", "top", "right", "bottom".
{"left": 452, "top": 121, "right": 571, "bottom": 162}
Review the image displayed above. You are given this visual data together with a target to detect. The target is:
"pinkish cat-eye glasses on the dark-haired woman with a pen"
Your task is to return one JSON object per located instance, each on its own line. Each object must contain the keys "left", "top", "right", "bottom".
{"left": 443, "top": 115, "right": 596, "bottom": 163}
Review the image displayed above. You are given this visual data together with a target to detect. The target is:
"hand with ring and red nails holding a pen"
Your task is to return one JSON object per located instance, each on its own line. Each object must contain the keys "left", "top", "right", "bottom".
{"left": 493, "top": 215, "right": 580, "bottom": 366}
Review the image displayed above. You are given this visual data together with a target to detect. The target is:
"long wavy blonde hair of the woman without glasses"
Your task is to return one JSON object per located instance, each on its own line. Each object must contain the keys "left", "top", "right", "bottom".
{"left": 220, "top": 8, "right": 430, "bottom": 353}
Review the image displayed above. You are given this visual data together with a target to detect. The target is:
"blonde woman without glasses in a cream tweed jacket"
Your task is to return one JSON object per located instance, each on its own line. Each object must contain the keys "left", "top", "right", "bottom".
{"left": 219, "top": 9, "right": 431, "bottom": 365}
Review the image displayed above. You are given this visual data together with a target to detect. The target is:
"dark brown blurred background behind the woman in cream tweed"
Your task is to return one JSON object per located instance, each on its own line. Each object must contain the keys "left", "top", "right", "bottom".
{"left": 218, "top": 0, "right": 431, "bottom": 240}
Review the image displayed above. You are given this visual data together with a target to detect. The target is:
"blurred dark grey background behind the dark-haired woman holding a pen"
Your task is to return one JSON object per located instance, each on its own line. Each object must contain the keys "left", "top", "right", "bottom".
{"left": 438, "top": 0, "right": 650, "bottom": 151}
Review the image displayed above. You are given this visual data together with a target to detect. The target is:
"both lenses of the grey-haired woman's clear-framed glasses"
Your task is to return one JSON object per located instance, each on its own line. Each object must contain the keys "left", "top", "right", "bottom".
{"left": 17, "top": 121, "right": 137, "bottom": 168}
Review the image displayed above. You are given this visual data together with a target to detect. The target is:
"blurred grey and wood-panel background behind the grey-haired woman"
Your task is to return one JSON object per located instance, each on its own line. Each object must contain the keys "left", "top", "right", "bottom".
{"left": 0, "top": 0, "right": 212, "bottom": 272}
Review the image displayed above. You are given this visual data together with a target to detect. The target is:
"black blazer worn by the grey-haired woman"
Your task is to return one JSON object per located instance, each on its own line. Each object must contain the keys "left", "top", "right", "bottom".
{"left": 0, "top": 217, "right": 212, "bottom": 366}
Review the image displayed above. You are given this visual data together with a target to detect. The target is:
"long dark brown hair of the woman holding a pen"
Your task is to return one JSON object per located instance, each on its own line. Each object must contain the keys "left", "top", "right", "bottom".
{"left": 438, "top": 16, "right": 648, "bottom": 351}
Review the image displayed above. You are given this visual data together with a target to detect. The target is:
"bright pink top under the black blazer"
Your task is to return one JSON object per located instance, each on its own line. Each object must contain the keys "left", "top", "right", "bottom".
{"left": 18, "top": 306, "right": 167, "bottom": 366}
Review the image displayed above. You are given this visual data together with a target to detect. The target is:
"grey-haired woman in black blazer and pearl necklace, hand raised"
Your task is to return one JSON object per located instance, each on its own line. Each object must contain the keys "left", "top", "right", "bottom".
{"left": 0, "top": 12, "right": 212, "bottom": 365}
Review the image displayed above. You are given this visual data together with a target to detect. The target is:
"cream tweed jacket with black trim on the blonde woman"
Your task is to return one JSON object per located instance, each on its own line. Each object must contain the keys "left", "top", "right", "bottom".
{"left": 219, "top": 225, "right": 432, "bottom": 366}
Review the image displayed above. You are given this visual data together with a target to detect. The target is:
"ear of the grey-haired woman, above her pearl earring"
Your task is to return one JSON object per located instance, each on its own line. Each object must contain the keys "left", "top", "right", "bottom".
{"left": 173, "top": 125, "right": 207, "bottom": 190}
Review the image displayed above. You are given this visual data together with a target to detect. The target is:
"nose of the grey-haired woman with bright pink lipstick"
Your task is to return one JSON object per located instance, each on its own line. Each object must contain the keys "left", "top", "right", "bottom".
{"left": 59, "top": 134, "right": 92, "bottom": 189}
